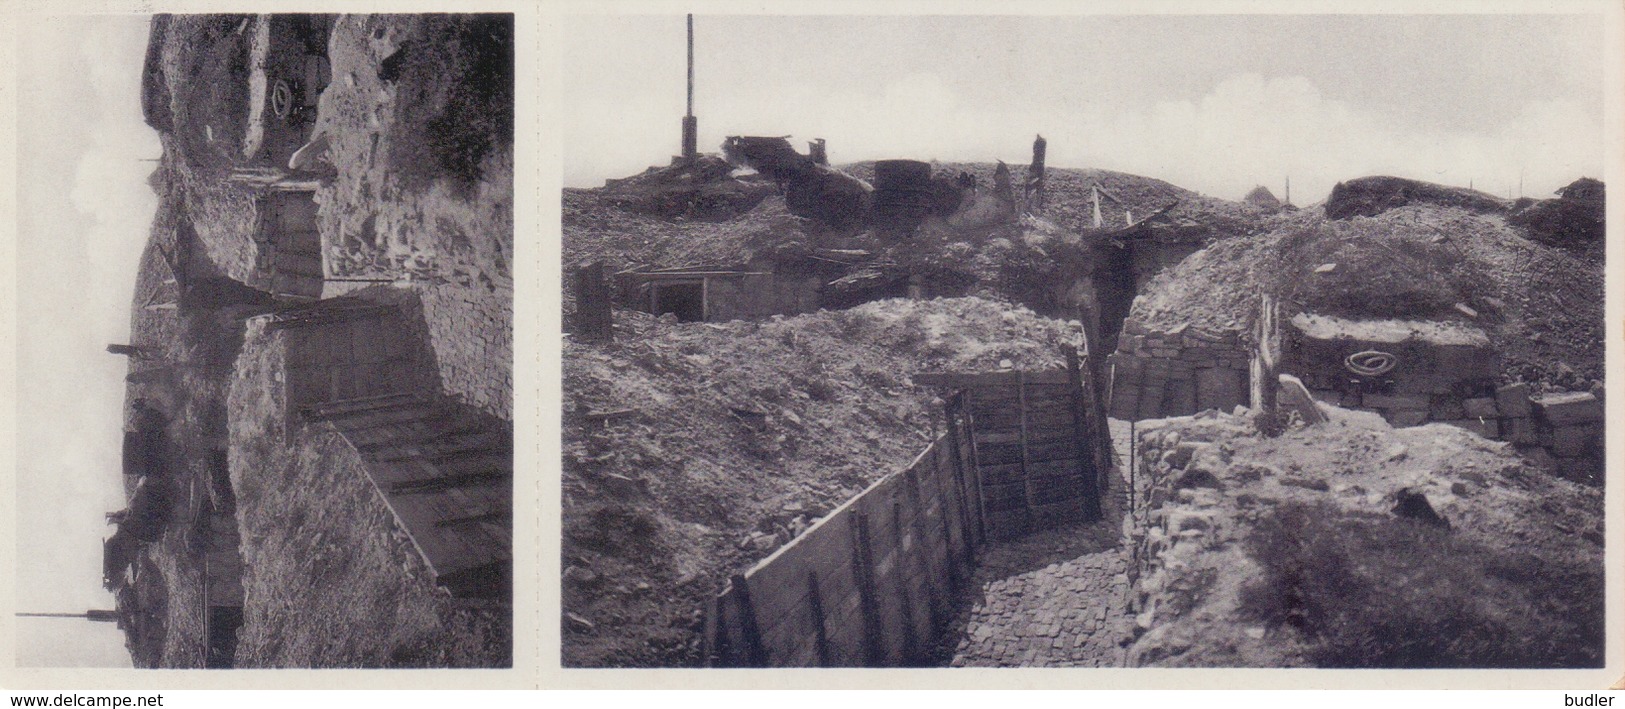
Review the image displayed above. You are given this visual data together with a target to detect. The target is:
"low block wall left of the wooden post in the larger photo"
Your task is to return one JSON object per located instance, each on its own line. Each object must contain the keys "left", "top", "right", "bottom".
{"left": 1108, "top": 319, "right": 1253, "bottom": 421}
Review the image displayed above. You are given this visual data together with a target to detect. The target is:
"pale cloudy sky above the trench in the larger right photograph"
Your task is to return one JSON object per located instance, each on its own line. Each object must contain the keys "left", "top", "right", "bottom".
{"left": 562, "top": 15, "right": 1604, "bottom": 205}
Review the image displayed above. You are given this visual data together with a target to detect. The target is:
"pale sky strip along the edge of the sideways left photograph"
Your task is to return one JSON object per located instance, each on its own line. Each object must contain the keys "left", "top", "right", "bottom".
{"left": 13, "top": 16, "right": 159, "bottom": 667}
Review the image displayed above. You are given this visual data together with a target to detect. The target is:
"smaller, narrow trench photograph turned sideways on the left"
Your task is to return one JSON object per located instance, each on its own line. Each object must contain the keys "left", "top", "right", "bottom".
{"left": 12, "top": 15, "right": 515, "bottom": 668}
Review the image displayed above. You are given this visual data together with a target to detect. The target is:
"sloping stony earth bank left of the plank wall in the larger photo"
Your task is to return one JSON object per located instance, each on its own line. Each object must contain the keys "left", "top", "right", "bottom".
{"left": 562, "top": 298, "right": 1079, "bottom": 667}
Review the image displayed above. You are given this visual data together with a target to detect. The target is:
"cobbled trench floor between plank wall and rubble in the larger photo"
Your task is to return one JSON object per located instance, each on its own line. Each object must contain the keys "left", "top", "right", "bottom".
{"left": 951, "top": 424, "right": 1134, "bottom": 667}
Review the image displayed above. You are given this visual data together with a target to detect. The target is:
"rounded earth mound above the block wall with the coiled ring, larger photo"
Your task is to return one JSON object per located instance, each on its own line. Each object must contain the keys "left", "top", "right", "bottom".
{"left": 1131, "top": 205, "right": 1604, "bottom": 389}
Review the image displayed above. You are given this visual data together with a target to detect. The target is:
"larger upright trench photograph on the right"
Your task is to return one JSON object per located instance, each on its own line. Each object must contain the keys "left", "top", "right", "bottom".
{"left": 562, "top": 13, "right": 1619, "bottom": 673}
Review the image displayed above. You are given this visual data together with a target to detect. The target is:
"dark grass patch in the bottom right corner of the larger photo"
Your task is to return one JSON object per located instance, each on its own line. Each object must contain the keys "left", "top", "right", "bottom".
{"left": 1242, "top": 504, "right": 1604, "bottom": 668}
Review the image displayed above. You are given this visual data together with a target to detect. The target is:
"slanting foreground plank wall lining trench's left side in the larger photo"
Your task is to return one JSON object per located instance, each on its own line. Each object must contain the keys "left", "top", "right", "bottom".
{"left": 705, "top": 431, "right": 982, "bottom": 667}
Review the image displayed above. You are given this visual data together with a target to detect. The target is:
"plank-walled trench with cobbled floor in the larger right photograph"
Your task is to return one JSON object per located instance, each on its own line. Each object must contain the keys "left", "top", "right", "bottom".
{"left": 704, "top": 359, "right": 1129, "bottom": 667}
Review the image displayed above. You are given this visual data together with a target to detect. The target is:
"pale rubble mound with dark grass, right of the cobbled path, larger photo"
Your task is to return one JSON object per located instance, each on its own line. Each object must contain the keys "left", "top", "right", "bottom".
{"left": 1129, "top": 410, "right": 1604, "bottom": 668}
